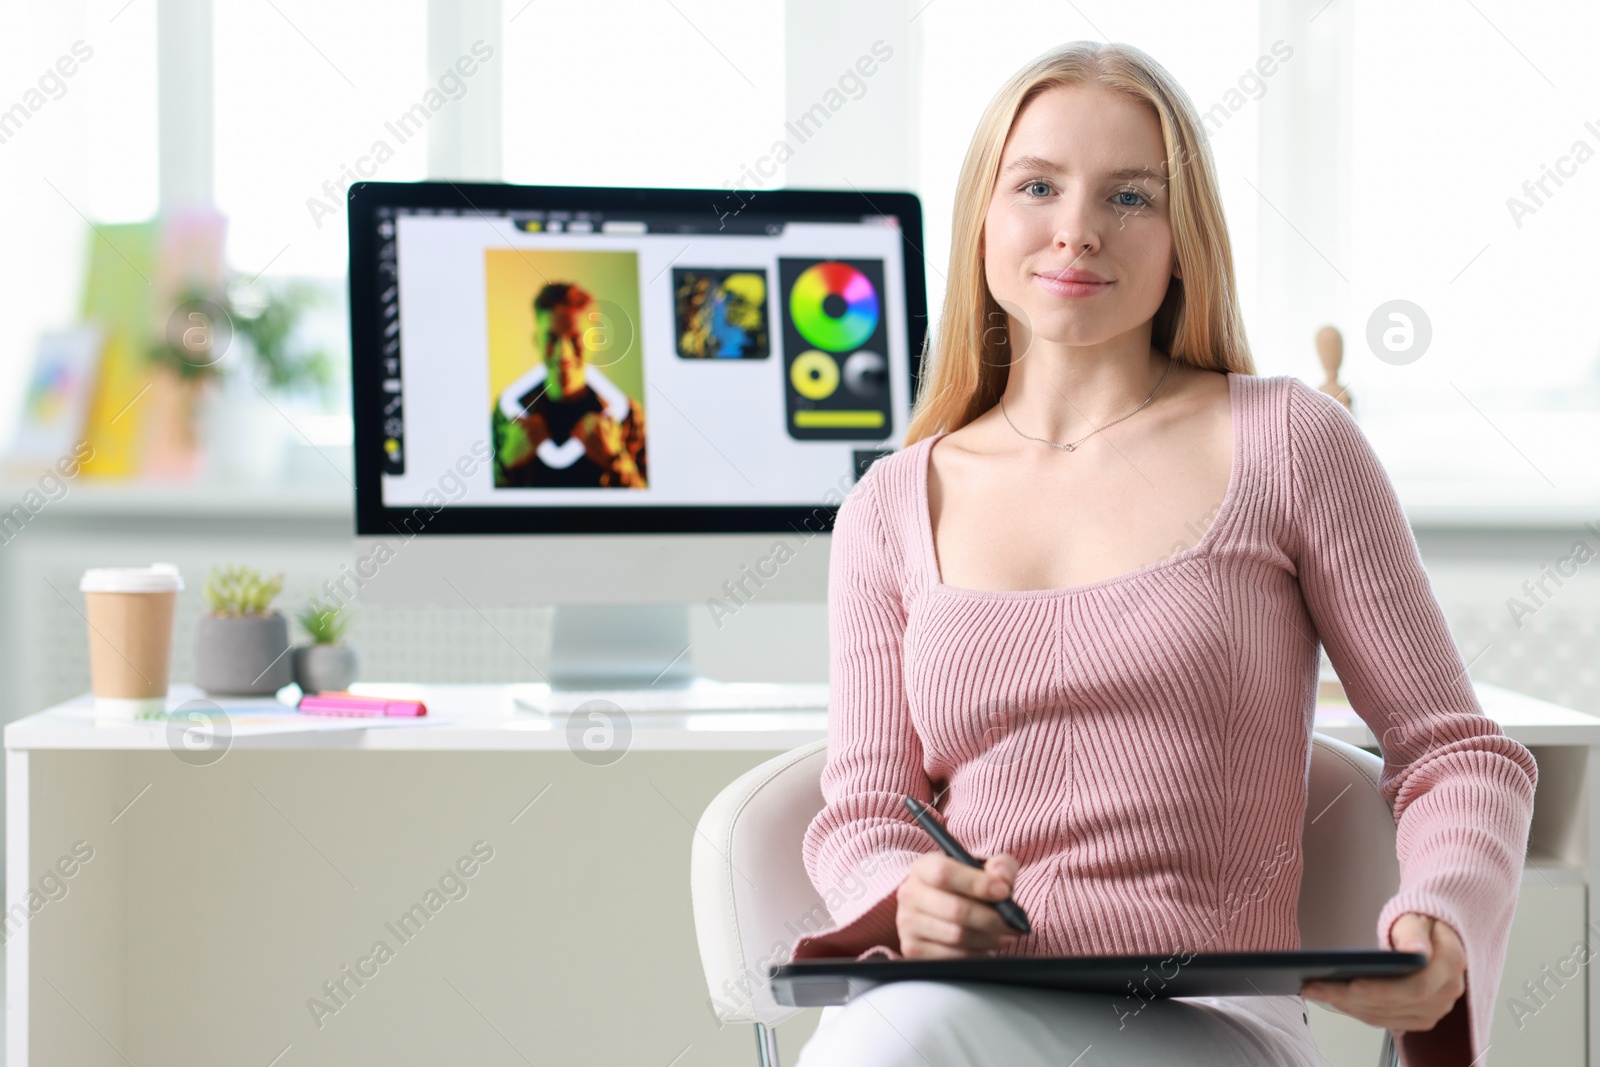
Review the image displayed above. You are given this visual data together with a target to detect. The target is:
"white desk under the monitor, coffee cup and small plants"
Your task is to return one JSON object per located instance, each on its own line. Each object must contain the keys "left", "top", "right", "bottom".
{"left": 5, "top": 685, "right": 1600, "bottom": 1067}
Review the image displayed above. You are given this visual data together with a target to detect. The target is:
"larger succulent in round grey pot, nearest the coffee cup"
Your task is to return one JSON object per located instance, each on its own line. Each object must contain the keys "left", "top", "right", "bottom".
{"left": 195, "top": 566, "right": 294, "bottom": 696}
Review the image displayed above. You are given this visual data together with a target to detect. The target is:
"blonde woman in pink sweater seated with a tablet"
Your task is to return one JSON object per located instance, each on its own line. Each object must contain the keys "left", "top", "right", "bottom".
{"left": 794, "top": 42, "right": 1538, "bottom": 1067}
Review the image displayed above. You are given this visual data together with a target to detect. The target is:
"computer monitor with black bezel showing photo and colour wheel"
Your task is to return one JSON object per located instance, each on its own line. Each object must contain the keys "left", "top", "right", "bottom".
{"left": 349, "top": 181, "right": 926, "bottom": 688}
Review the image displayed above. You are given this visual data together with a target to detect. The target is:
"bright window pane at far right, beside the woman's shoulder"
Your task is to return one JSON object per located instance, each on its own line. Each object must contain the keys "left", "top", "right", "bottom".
{"left": 1341, "top": 0, "right": 1600, "bottom": 509}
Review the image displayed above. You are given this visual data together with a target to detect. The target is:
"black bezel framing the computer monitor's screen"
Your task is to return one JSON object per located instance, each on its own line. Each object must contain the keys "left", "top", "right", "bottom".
{"left": 347, "top": 181, "right": 928, "bottom": 536}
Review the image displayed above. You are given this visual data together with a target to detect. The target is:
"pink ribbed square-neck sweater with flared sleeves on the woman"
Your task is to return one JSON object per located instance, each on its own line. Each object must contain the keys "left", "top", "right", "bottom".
{"left": 792, "top": 374, "right": 1538, "bottom": 1067}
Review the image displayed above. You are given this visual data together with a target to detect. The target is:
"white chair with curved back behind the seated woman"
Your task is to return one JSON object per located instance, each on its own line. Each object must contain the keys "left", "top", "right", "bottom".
{"left": 690, "top": 734, "right": 1400, "bottom": 1067}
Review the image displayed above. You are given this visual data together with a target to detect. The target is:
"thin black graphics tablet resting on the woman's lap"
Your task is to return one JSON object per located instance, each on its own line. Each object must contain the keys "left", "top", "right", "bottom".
{"left": 768, "top": 949, "right": 1427, "bottom": 1008}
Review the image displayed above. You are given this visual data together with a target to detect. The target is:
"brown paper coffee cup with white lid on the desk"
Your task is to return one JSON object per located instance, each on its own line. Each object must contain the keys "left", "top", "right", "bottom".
{"left": 78, "top": 563, "right": 184, "bottom": 721}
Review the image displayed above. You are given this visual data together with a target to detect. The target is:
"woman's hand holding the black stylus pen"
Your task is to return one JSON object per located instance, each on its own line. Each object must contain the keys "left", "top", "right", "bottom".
{"left": 894, "top": 853, "right": 1022, "bottom": 960}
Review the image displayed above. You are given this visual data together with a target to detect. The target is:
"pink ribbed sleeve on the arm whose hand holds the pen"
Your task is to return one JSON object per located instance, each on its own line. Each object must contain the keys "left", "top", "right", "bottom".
{"left": 790, "top": 467, "right": 934, "bottom": 960}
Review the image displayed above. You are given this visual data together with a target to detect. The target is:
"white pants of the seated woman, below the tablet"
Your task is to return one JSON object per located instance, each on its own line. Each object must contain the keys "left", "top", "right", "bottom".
{"left": 797, "top": 981, "right": 1322, "bottom": 1067}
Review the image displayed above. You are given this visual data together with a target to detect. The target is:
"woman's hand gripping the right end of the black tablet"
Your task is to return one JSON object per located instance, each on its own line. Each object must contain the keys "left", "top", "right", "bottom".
{"left": 1301, "top": 912, "right": 1467, "bottom": 1032}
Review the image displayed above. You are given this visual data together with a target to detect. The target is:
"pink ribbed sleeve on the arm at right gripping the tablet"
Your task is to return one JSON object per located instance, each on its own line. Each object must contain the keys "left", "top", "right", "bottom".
{"left": 1286, "top": 378, "right": 1539, "bottom": 1067}
